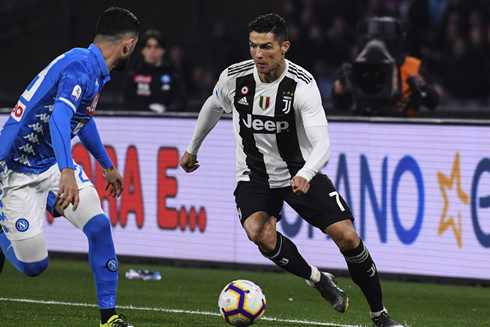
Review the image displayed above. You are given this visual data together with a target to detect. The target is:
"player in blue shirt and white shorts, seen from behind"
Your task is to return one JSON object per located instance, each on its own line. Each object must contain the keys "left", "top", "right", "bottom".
{"left": 0, "top": 7, "right": 140, "bottom": 327}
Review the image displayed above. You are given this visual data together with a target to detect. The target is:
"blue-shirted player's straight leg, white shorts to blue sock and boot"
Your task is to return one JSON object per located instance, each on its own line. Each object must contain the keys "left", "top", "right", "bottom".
{"left": 48, "top": 165, "right": 129, "bottom": 327}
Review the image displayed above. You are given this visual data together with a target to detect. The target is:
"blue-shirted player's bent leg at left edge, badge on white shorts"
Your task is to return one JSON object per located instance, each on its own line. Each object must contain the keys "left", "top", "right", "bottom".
{"left": 0, "top": 166, "right": 52, "bottom": 277}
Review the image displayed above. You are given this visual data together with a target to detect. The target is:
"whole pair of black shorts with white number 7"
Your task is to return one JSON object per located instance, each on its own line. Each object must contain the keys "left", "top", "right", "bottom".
{"left": 233, "top": 174, "right": 354, "bottom": 232}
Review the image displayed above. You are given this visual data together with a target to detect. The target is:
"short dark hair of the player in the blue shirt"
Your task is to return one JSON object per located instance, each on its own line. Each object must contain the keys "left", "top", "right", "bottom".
{"left": 95, "top": 7, "right": 140, "bottom": 41}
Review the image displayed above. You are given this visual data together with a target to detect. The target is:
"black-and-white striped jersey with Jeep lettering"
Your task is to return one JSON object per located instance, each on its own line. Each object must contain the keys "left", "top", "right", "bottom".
{"left": 212, "top": 60, "right": 328, "bottom": 188}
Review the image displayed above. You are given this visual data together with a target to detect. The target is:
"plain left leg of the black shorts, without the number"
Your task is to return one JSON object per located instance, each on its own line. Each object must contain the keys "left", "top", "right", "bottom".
{"left": 233, "top": 182, "right": 283, "bottom": 225}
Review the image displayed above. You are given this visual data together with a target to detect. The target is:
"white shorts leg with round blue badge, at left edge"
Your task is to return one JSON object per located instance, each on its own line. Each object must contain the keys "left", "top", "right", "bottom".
{"left": 0, "top": 163, "right": 56, "bottom": 241}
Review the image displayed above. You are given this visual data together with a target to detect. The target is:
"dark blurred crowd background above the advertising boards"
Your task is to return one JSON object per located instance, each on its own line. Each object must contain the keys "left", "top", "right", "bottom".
{"left": 0, "top": 0, "right": 490, "bottom": 118}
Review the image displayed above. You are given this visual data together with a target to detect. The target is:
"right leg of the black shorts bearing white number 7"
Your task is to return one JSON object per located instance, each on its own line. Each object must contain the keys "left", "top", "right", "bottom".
{"left": 285, "top": 174, "right": 354, "bottom": 232}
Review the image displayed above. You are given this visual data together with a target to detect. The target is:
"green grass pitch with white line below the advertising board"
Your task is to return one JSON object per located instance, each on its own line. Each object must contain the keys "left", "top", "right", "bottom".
{"left": 0, "top": 259, "right": 490, "bottom": 327}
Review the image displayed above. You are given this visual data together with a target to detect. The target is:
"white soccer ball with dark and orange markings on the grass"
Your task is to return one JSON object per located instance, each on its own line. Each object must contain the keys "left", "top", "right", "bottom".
{"left": 218, "top": 279, "right": 265, "bottom": 326}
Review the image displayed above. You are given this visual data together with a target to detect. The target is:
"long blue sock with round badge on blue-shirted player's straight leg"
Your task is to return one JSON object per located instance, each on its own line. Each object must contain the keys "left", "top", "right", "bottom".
{"left": 83, "top": 214, "right": 119, "bottom": 309}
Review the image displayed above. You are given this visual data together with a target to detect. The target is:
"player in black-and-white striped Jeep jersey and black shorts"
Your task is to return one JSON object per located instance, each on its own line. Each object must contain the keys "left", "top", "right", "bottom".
{"left": 180, "top": 14, "right": 401, "bottom": 327}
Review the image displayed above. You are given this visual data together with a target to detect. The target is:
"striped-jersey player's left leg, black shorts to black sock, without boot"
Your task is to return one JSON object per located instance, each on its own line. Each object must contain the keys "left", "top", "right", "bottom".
{"left": 234, "top": 182, "right": 312, "bottom": 284}
